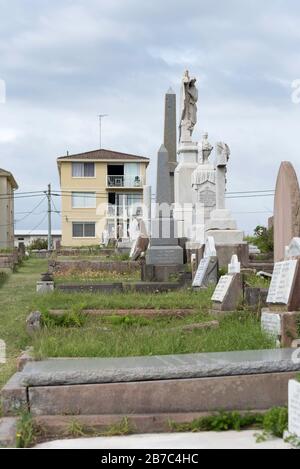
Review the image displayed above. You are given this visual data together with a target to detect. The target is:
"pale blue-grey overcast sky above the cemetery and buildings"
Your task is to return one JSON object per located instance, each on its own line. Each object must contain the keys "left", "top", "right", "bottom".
{"left": 0, "top": 0, "right": 300, "bottom": 232}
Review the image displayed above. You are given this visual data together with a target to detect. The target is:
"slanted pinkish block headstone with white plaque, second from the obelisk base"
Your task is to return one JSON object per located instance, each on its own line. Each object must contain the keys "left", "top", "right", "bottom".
{"left": 212, "top": 274, "right": 242, "bottom": 312}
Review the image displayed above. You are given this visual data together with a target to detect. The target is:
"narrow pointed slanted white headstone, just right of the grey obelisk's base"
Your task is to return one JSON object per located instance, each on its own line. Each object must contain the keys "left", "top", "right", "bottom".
{"left": 192, "top": 237, "right": 218, "bottom": 288}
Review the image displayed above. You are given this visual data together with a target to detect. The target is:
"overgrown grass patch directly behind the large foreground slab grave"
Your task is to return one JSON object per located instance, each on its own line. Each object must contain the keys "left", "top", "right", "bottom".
{"left": 33, "top": 313, "right": 275, "bottom": 358}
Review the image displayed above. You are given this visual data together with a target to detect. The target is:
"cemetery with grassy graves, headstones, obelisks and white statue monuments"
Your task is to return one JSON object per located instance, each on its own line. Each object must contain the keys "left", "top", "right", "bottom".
{"left": 0, "top": 72, "right": 300, "bottom": 445}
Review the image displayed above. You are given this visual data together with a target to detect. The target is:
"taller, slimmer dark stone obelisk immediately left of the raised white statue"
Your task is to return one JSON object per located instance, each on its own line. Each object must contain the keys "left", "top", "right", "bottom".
{"left": 164, "top": 88, "right": 177, "bottom": 203}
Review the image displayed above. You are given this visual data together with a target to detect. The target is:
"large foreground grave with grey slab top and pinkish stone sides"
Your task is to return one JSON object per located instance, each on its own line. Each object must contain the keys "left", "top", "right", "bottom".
{"left": 1, "top": 349, "right": 300, "bottom": 421}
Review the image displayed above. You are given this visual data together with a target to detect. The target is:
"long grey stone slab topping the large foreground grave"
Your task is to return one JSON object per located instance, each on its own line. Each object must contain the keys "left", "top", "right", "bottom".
{"left": 20, "top": 349, "right": 300, "bottom": 387}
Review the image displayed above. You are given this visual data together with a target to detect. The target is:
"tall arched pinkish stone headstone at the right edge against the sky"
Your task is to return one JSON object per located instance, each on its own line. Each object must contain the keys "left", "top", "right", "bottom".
{"left": 274, "top": 161, "right": 300, "bottom": 262}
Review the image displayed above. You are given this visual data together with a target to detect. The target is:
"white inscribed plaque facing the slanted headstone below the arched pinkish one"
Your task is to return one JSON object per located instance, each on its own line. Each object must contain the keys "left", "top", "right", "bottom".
{"left": 267, "top": 260, "right": 298, "bottom": 305}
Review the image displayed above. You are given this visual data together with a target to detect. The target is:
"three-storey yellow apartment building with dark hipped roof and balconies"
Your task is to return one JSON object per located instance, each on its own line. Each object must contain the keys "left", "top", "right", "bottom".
{"left": 57, "top": 150, "right": 149, "bottom": 246}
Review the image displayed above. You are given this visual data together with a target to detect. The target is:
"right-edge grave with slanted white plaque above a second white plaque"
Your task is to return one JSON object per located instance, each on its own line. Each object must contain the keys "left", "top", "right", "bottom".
{"left": 261, "top": 239, "right": 300, "bottom": 347}
